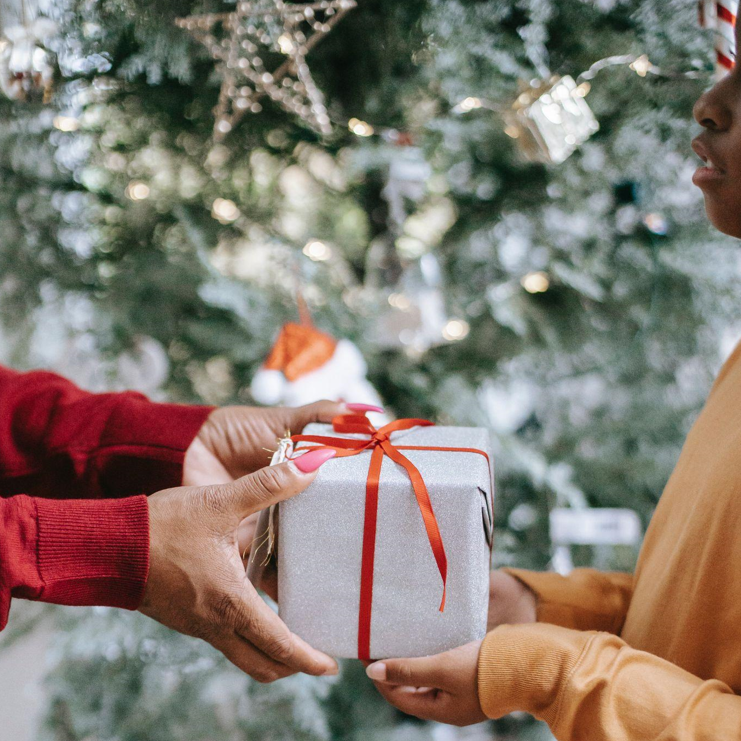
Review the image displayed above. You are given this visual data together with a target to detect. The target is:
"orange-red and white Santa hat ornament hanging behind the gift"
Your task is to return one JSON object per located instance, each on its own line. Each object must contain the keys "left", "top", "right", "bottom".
{"left": 250, "top": 312, "right": 382, "bottom": 422}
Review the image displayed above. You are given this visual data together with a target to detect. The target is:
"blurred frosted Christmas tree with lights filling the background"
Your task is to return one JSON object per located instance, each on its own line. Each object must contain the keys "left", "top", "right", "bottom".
{"left": 0, "top": 0, "right": 739, "bottom": 741}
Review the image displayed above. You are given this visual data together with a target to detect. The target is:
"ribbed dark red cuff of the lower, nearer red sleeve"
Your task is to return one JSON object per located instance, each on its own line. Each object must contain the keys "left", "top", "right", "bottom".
{"left": 33, "top": 496, "right": 149, "bottom": 610}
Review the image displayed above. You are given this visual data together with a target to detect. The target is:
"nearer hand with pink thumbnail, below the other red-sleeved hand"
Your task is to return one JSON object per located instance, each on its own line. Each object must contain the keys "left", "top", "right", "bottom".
{"left": 139, "top": 450, "right": 337, "bottom": 682}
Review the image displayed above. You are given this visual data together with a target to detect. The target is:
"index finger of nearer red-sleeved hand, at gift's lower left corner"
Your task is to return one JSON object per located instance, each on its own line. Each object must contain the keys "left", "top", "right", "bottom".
{"left": 238, "top": 582, "right": 339, "bottom": 676}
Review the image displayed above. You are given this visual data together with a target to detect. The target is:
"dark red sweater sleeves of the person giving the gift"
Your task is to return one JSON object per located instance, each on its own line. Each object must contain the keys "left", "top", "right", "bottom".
{"left": 0, "top": 366, "right": 211, "bottom": 630}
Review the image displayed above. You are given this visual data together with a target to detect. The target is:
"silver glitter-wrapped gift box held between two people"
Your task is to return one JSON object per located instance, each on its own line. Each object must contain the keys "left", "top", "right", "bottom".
{"left": 278, "top": 424, "right": 493, "bottom": 659}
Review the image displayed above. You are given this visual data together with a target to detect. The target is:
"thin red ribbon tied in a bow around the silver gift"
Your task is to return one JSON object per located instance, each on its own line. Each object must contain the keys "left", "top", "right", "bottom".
{"left": 291, "top": 414, "right": 489, "bottom": 661}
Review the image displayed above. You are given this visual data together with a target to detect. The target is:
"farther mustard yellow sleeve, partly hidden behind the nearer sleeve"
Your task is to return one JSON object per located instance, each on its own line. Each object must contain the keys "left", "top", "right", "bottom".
{"left": 504, "top": 569, "right": 633, "bottom": 633}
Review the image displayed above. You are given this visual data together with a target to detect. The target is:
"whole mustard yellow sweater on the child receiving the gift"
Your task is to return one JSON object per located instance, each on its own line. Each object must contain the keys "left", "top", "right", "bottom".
{"left": 479, "top": 346, "right": 741, "bottom": 741}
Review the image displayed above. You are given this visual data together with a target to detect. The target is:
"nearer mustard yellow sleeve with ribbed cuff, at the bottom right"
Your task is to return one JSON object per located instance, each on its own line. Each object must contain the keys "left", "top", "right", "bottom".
{"left": 478, "top": 623, "right": 741, "bottom": 741}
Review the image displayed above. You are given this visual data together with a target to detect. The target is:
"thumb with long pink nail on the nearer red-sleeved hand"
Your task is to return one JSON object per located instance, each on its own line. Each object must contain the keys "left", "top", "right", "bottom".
{"left": 209, "top": 448, "right": 337, "bottom": 525}
